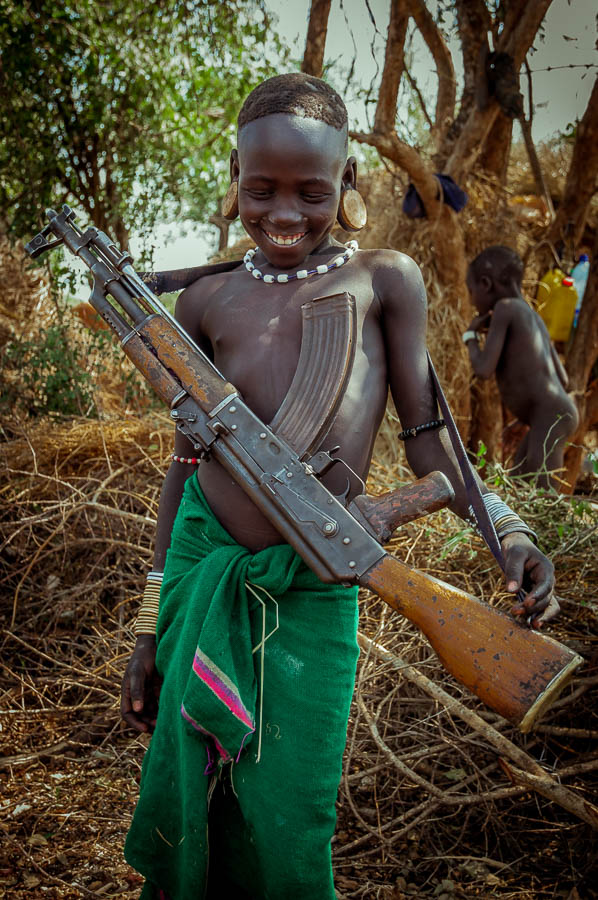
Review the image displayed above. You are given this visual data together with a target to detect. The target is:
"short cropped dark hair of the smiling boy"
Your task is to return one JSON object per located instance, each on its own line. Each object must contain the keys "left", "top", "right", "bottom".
{"left": 237, "top": 72, "right": 347, "bottom": 131}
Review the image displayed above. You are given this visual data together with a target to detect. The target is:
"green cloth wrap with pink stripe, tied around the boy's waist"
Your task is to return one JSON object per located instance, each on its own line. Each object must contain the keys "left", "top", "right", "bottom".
{"left": 125, "top": 477, "right": 358, "bottom": 900}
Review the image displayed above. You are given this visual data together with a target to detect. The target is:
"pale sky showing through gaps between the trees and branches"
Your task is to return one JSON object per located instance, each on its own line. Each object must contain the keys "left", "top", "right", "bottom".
{"left": 132, "top": 0, "right": 598, "bottom": 269}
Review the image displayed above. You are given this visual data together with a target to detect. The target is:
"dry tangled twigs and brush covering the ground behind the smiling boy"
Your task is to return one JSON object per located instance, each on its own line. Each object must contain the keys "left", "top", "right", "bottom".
{"left": 0, "top": 416, "right": 598, "bottom": 900}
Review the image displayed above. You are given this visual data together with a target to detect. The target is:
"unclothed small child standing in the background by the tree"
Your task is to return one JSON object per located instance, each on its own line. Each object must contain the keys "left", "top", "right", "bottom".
{"left": 463, "top": 245, "right": 578, "bottom": 487}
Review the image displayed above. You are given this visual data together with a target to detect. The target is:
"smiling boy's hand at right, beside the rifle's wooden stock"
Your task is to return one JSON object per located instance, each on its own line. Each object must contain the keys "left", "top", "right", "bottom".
{"left": 501, "top": 531, "right": 560, "bottom": 628}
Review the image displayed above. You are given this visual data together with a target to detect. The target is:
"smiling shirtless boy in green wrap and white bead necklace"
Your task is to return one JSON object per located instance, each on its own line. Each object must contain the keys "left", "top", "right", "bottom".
{"left": 122, "top": 74, "right": 558, "bottom": 900}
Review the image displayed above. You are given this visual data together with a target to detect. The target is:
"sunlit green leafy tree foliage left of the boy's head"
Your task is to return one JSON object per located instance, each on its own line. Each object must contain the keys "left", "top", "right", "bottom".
{"left": 0, "top": 0, "right": 276, "bottom": 243}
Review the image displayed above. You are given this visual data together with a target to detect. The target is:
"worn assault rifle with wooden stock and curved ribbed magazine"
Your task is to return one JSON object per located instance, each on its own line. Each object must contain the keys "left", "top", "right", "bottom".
{"left": 26, "top": 205, "right": 582, "bottom": 731}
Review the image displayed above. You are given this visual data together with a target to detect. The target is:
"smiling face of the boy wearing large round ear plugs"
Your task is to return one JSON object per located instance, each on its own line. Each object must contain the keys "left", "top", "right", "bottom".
{"left": 231, "top": 114, "right": 355, "bottom": 269}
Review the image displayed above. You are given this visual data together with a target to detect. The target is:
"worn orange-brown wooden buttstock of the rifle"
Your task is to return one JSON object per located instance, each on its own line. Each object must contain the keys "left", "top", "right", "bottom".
{"left": 359, "top": 555, "right": 583, "bottom": 732}
